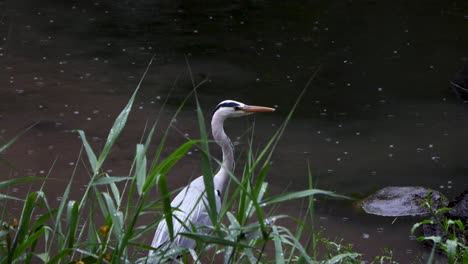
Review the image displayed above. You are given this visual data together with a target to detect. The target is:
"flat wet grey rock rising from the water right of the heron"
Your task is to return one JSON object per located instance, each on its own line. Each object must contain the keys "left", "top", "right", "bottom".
{"left": 361, "top": 186, "right": 447, "bottom": 216}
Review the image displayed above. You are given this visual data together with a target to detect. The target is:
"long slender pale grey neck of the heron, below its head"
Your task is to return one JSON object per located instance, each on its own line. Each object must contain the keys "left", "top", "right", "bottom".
{"left": 211, "top": 114, "right": 234, "bottom": 195}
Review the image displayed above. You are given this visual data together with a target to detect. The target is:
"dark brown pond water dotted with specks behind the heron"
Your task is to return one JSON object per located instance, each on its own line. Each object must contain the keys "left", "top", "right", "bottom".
{"left": 0, "top": 0, "right": 468, "bottom": 263}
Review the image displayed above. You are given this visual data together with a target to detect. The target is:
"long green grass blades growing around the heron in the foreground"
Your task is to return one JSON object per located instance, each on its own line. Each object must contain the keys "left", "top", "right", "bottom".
{"left": 0, "top": 60, "right": 466, "bottom": 264}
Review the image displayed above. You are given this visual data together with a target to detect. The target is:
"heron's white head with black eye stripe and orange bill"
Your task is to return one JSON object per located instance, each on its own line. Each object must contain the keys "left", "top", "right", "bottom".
{"left": 213, "top": 100, "right": 275, "bottom": 118}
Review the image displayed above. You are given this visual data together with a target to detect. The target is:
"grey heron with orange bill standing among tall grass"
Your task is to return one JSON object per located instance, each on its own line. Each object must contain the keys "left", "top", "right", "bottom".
{"left": 149, "top": 100, "right": 275, "bottom": 256}
